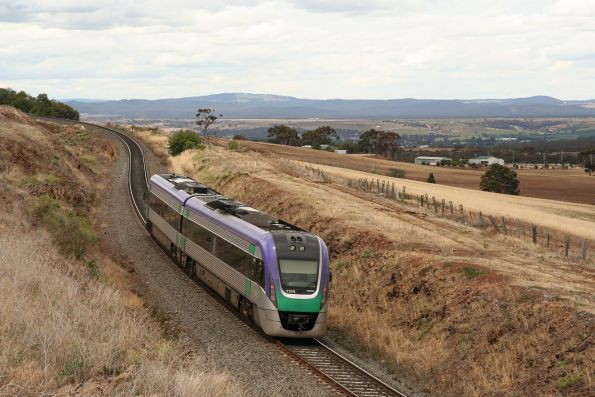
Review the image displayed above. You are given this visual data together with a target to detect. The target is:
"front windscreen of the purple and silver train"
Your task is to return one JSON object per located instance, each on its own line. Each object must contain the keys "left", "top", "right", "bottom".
{"left": 279, "top": 259, "right": 318, "bottom": 294}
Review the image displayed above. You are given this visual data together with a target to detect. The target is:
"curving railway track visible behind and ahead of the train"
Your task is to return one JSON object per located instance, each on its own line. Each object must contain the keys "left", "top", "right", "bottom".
{"left": 33, "top": 116, "right": 406, "bottom": 397}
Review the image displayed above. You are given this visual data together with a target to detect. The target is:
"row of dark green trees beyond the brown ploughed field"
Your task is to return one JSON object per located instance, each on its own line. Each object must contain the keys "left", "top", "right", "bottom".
{"left": 267, "top": 125, "right": 400, "bottom": 159}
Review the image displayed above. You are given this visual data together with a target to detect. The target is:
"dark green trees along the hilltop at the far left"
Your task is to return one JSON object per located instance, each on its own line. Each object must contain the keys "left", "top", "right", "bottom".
{"left": 0, "top": 88, "right": 79, "bottom": 120}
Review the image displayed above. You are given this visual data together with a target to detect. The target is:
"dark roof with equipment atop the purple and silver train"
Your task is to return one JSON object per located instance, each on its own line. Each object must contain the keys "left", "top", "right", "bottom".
{"left": 151, "top": 174, "right": 303, "bottom": 232}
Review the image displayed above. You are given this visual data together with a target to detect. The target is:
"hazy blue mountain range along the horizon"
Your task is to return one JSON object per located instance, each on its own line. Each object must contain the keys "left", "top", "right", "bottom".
{"left": 65, "top": 93, "right": 595, "bottom": 120}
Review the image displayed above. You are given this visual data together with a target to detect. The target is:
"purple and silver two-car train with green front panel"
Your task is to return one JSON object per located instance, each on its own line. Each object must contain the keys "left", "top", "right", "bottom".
{"left": 147, "top": 174, "right": 331, "bottom": 338}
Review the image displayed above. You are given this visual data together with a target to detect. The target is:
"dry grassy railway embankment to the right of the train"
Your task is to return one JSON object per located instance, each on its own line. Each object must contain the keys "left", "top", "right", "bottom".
{"left": 124, "top": 127, "right": 595, "bottom": 395}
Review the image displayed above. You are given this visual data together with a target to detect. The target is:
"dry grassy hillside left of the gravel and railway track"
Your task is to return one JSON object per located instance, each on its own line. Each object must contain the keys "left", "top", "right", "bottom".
{"left": 0, "top": 106, "right": 243, "bottom": 397}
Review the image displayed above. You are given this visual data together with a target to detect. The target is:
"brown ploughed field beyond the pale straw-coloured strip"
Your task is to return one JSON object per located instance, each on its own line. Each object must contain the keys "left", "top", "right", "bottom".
{"left": 242, "top": 142, "right": 595, "bottom": 204}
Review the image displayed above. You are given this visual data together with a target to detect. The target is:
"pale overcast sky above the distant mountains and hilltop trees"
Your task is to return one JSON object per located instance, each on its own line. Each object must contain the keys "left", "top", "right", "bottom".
{"left": 0, "top": 0, "right": 595, "bottom": 99}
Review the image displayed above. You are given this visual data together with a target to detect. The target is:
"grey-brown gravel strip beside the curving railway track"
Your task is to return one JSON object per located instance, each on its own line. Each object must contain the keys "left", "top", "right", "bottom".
{"left": 92, "top": 127, "right": 337, "bottom": 396}
